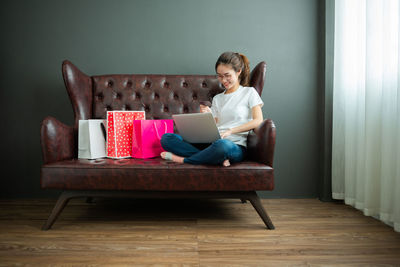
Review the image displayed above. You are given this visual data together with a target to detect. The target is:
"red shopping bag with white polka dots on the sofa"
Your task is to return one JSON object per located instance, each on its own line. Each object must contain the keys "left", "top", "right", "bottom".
{"left": 107, "top": 111, "right": 145, "bottom": 159}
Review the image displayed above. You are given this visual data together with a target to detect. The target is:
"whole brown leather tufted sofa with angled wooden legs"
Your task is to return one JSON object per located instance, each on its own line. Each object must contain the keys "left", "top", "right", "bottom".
{"left": 41, "top": 60, "right": 276, "bottom": 230}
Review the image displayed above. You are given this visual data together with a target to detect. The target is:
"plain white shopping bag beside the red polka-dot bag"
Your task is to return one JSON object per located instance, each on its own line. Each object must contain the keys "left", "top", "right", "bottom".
{"left": 78, "top": 120, "right": 107, "bottom": 159}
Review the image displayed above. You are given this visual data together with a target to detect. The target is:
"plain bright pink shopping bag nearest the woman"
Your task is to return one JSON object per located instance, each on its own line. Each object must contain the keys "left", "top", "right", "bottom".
{"left": 132, "top": 120, "right": 174, "bottom": 159}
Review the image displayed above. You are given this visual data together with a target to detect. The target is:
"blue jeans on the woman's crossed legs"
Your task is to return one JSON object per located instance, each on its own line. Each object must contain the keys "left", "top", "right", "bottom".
{"left": 161, "top": 133, "right": 246, "bottom": 165}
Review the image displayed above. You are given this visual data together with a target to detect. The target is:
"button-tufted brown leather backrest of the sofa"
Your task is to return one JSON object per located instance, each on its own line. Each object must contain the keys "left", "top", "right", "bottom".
{"left": 92, "top": 75, "right": 223, "bottom": 119}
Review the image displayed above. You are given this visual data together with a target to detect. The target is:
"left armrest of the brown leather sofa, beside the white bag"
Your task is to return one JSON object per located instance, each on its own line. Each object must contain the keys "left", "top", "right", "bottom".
{"left": 40, "top": 117, "right": 75, "bottom": 164}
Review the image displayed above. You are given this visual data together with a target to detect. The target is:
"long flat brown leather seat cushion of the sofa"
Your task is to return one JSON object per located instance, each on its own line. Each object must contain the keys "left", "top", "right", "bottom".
{"left": 41, "top": 158, "right": 274, "bottom": 191}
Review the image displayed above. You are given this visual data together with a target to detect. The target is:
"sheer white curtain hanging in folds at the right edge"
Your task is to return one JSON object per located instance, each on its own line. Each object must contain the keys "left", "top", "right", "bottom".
{"left": 332, "top": 0, "right": 400, "bottom": 231}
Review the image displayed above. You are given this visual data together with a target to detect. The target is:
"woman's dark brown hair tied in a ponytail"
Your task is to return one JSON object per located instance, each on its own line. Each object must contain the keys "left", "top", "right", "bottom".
{"left": 215, "top": 52, "right": 250, "bottom": 86}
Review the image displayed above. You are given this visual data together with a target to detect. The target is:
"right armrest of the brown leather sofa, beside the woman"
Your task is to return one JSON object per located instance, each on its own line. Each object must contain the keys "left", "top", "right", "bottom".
{"left": 247, "top": 119, "right": 276, "bottom": 167}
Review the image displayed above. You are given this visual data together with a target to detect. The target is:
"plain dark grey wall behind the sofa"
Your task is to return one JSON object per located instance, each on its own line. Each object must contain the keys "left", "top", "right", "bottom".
{"left": 0, "top": 0, "right": 323, "bottom": 197}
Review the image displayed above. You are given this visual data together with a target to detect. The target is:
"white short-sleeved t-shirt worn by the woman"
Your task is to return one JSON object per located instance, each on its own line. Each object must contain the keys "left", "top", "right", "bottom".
{"left": 211, "top": 86, "right": 264, "bottom": 147}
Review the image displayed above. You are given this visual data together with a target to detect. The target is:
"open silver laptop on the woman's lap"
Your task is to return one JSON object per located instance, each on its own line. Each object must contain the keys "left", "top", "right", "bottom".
{"left": 172, "top": 112, "right": 221, "bottom": 144}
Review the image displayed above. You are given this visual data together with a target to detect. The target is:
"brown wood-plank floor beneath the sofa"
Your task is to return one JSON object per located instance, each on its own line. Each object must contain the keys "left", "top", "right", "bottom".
{"left": 0, "top": 199, "right": 400, "bottom": 266}
